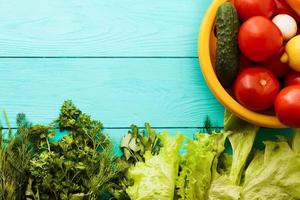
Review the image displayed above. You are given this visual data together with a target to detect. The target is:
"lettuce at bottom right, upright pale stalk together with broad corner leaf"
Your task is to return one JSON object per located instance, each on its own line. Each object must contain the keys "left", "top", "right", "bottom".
{"left": 208, "top": 119, "right": 300, "bottom": 200}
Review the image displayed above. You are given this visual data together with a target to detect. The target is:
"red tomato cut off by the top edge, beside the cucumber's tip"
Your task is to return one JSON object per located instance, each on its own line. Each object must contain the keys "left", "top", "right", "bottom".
{"left": 234, "top": 0, "right": 276, "bottom": 21}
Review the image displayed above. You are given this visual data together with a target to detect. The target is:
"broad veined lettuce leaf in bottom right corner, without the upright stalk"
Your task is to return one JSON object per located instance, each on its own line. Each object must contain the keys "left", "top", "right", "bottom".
{"left": 242, "top": 131, "right": 300, "bottom": 200}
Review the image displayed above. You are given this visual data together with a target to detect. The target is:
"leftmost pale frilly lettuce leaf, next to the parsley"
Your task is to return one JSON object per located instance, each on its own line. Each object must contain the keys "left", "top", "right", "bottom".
{"left": 126, "top": 132, "right": 185, "bottom": 200}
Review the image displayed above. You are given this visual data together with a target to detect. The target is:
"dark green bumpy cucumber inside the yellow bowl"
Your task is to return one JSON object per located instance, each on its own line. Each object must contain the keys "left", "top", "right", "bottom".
{"left": 215, "top": 2, "right": 240, "bottom": 88}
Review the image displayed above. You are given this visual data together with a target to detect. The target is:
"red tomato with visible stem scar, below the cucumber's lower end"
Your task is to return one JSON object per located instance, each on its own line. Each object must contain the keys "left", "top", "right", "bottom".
{"left": 234, "top": 67, "right": 279, "bottom": 111}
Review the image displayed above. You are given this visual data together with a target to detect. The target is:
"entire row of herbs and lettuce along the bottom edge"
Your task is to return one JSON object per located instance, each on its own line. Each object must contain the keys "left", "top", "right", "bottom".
{"left": 0, "top": 101, "right": 300, "bottom": 200}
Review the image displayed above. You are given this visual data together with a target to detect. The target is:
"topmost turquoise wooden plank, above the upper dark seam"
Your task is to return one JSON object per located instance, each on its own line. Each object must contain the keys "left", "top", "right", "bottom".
{"left": 0, "top": 0, "right": 211, "bottom": 57}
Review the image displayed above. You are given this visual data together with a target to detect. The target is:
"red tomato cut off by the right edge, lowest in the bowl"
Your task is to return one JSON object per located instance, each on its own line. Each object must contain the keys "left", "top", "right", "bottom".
{"left": 275, "top": 85, "right": 300, "bottom": 128}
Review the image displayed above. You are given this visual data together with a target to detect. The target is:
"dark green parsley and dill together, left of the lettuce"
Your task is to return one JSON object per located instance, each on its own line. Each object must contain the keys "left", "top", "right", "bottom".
{"left": 0, "top": 101, "right": 128, "bottom": 200}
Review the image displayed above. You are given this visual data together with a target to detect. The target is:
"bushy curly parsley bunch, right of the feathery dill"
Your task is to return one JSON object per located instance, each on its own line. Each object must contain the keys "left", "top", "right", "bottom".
{"left": 26, "top": 101, "right": 127, "bottom": 200}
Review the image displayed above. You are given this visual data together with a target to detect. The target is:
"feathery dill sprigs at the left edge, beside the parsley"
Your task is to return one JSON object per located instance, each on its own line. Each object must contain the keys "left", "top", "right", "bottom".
{"left": 0, "top": 112, "right": 49, "bottom": 200}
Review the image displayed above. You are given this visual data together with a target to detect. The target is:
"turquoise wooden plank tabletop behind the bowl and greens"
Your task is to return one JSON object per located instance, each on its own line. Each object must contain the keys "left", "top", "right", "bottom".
{"left": 0, "top": 0, "right": 290, "bottom": 145}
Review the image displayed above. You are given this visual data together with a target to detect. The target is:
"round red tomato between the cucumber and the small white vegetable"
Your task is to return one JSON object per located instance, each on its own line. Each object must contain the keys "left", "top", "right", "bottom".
{"left": 238, "top": 16, "right": 283, "bottom": 62}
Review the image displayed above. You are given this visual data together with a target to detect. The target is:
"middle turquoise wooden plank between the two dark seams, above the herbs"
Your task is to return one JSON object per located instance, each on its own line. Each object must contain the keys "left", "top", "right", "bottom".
{"left": 0, "top": 58, "right": 223, "bottom": 127}
